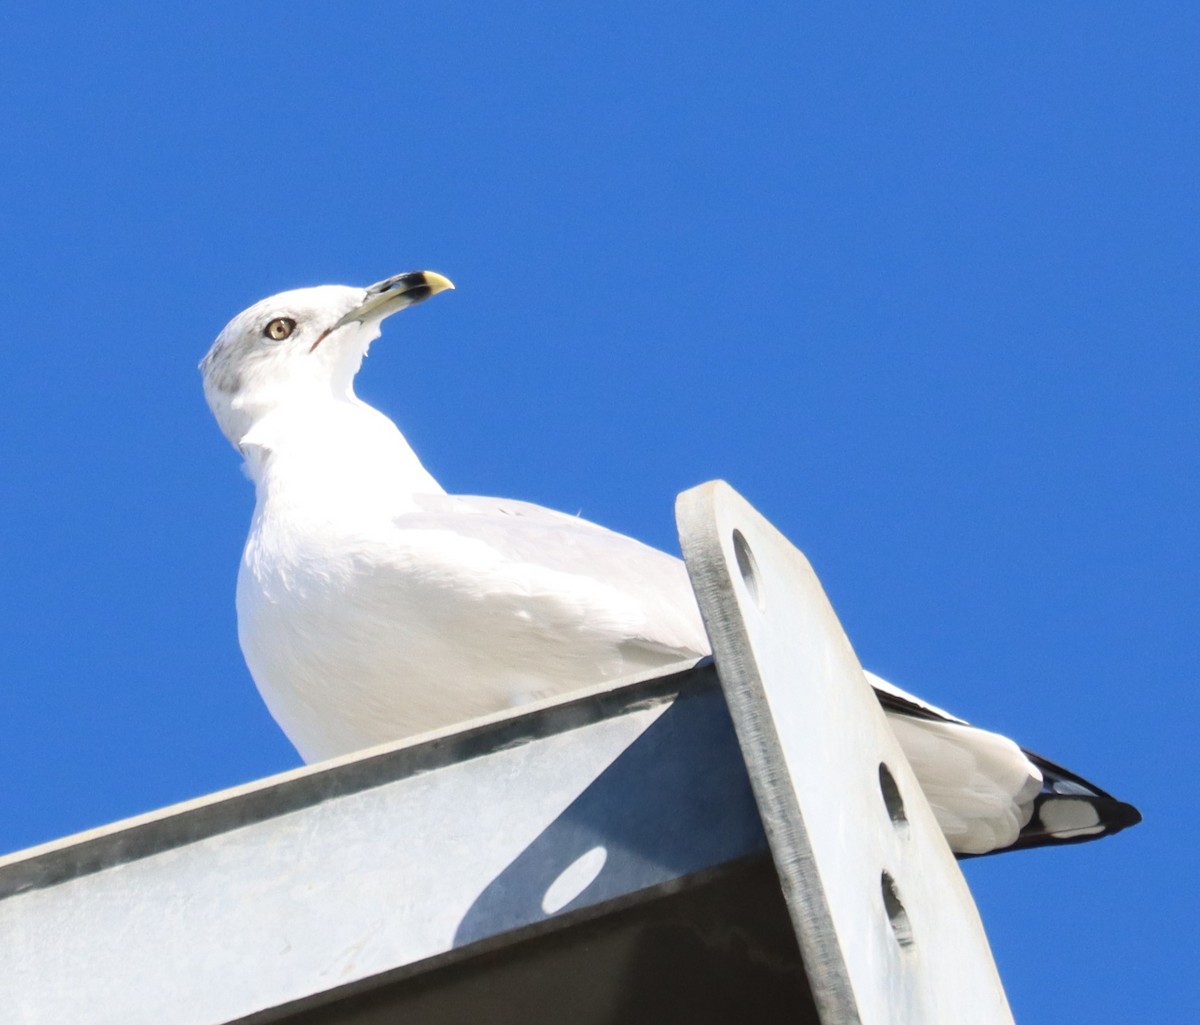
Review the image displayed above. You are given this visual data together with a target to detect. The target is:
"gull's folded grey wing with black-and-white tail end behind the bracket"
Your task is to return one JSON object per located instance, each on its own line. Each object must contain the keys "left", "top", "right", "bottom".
{"left": 396, "top": 494, "right": 1141, "bottom": 856}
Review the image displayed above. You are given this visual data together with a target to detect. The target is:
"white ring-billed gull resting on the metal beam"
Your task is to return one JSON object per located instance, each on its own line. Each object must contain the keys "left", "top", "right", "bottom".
{"left": 200, "top": 271, "right": 1140, "bottom": 855}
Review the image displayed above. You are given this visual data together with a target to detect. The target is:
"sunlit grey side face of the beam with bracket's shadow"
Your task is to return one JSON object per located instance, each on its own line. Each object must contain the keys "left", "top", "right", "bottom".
{"left": 0, "top": 666, "right": 764, "bottom": 1025}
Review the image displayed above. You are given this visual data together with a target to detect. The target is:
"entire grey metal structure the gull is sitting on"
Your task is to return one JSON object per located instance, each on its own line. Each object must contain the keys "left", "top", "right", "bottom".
{"left": 0, "top": 485, "right": 1010, "bottom": 1025}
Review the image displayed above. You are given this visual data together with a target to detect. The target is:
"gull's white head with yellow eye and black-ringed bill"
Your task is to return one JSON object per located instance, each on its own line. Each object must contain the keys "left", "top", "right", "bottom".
{"left": 200, "top": 270, "right": 454, "bottom": 448}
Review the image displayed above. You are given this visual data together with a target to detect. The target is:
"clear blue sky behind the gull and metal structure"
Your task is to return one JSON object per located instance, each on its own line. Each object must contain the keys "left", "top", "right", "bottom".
{"left": 0, "top": 2, "right": 1200, "bottom": 1023}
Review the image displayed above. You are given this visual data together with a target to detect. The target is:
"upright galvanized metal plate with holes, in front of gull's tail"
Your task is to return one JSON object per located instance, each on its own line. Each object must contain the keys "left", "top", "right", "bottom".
{"left": 676, "top": 481, "right": 1013, "bottom": 1025}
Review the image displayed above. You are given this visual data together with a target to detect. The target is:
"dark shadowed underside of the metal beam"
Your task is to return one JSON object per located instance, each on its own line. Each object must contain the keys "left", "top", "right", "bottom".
{"left": 264, "top": 853, "right": 821, "bottom": 1025}
